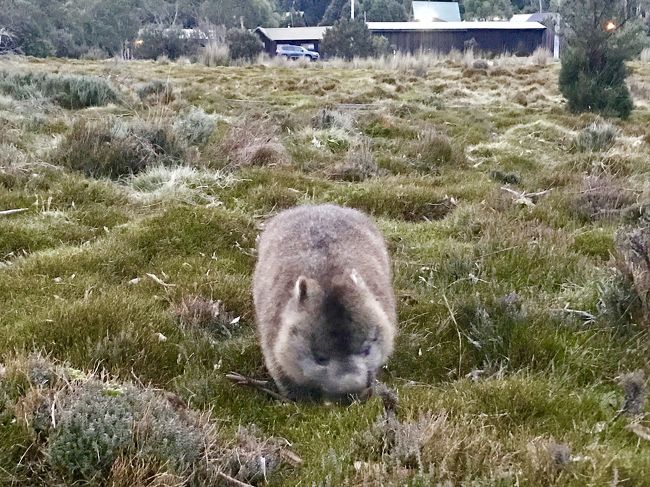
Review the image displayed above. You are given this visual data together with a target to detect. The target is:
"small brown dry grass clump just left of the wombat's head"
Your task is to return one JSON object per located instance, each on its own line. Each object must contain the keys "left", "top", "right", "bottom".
{"left": 171, "top": 295, "right": 239, "bottom": 338}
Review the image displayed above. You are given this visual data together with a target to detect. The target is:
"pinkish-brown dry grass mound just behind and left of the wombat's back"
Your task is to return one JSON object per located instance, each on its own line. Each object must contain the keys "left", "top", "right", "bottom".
{"left": 221, "top": 116, "right": 291, "bottom": 167}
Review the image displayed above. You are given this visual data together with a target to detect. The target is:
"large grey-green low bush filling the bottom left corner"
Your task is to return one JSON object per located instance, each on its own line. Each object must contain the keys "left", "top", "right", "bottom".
{"left": 0, "top": 356, "right": 294, "bottom": 485}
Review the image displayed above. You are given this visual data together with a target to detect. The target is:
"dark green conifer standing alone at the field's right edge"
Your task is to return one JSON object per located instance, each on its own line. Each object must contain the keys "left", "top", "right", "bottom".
{"left": 560, "top": 0, "right": 644, "bottom": 118}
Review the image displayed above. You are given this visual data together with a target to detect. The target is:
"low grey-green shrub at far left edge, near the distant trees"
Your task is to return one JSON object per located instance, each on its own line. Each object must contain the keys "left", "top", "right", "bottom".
{"left": 0, "top": 71, "right": 119, "bottom": 109}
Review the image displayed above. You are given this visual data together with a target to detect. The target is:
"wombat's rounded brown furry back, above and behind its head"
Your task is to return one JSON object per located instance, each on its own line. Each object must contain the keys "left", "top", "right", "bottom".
{"left": 253, "top": 205, "right": 394, "bottom": 320}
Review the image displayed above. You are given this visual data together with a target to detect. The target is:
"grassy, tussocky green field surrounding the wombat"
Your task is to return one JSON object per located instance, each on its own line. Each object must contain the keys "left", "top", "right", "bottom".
{"left": 0, "top": 51, "right": 650, "bottom": 486}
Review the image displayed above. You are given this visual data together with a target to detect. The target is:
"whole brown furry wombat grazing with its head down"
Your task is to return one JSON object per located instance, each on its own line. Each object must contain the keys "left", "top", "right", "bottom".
{"left": 253, "top": 205, "right": 397, "bottom": 399}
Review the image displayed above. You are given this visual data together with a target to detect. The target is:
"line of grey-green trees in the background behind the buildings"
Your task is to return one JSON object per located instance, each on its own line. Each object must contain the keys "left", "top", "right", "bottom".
{"left": 0, "top": 0, "right": 650, "bottom": 57}
